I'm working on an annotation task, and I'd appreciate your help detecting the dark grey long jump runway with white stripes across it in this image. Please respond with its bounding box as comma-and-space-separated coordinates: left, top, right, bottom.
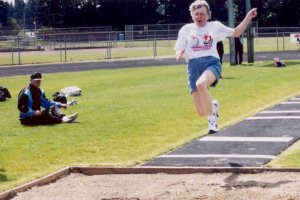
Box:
142, 96, 300, 167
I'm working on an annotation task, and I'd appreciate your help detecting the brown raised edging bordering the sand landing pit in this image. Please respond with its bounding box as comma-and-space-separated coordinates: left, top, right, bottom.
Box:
0, 166, 300, 200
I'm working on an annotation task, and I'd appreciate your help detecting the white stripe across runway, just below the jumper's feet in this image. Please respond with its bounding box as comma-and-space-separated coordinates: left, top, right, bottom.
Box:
198, 136, 294, 142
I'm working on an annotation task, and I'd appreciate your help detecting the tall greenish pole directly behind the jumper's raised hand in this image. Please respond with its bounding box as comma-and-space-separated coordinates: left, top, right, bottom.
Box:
246, 0, 254, 63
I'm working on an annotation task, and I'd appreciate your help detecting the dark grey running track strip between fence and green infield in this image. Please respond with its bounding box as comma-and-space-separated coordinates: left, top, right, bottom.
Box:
0, 51, 300, 77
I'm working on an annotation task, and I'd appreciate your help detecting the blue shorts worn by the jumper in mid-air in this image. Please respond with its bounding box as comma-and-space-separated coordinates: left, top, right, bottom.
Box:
187, 56, 222, 93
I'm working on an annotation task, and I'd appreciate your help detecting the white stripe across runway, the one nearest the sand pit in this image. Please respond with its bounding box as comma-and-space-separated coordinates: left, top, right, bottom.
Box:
159, 154, 276, 159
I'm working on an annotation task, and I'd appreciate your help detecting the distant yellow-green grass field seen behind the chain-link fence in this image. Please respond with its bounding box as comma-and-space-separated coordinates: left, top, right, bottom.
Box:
0, 37, 300, 65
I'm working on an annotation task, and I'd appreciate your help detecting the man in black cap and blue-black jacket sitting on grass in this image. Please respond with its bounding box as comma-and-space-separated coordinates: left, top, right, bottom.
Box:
18, 72, 78, 125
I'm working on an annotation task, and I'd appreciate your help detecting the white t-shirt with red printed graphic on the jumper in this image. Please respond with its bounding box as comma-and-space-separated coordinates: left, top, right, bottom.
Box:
175, 21, 234, 61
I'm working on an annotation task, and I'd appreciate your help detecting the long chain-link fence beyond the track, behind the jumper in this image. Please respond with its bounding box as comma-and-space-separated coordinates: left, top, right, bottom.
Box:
0, 24, 300, 65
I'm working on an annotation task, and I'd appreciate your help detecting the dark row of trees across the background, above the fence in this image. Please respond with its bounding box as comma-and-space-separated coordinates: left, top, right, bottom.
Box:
0, 0, 300, 30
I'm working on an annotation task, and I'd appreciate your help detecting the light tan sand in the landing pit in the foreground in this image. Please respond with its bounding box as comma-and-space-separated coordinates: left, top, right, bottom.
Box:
14, 172, 300, 200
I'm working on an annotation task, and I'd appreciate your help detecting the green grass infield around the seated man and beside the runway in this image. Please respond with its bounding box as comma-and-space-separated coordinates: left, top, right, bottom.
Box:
0, 61, 300, 191
